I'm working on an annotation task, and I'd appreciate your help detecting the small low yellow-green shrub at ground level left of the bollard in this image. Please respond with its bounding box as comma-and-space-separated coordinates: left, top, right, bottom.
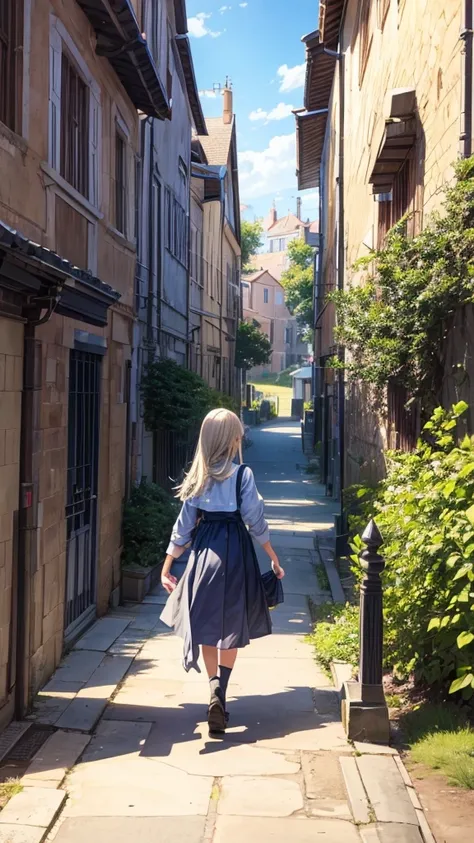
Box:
310, 603, 359, 670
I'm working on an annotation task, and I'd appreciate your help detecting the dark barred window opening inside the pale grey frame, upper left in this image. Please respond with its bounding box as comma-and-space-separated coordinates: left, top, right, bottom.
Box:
60, 52, 89, 196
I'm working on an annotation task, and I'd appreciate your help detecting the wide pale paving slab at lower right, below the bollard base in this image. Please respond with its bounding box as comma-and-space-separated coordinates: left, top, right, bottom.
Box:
356, 755, 418, 826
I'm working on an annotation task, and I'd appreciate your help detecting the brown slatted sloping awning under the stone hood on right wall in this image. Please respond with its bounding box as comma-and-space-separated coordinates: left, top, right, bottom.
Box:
369, 118, 416, 194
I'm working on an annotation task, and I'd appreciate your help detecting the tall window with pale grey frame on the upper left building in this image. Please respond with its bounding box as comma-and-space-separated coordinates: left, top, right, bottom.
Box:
49, 16, 100, 207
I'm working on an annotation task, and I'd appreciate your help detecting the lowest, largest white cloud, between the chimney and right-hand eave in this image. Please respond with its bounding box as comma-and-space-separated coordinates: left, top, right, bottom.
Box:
239, 132, 296, 202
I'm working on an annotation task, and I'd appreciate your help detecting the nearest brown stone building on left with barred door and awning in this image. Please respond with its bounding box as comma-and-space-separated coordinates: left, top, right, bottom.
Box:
0, 0, 165, 725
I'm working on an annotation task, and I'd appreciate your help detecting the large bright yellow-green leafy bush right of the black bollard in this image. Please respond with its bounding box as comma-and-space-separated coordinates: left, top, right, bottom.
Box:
352, 402, 474, 699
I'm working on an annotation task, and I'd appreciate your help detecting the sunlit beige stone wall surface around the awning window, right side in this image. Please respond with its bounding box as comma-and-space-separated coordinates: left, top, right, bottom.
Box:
322, 0, 462, 485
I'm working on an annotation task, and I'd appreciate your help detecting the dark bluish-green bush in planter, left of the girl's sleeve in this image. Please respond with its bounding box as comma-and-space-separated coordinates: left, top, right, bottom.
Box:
122, 481, 180, 568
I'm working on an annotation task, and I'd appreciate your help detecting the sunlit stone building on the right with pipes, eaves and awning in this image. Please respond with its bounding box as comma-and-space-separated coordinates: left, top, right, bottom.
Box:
296, 0, 474, 495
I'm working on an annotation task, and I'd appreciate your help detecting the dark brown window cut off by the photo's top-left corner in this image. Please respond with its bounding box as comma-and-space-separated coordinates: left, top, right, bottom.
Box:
0, 0, 23, 132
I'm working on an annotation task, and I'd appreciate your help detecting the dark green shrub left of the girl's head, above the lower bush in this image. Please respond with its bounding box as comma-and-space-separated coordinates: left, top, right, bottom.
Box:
140, 360, 237, 432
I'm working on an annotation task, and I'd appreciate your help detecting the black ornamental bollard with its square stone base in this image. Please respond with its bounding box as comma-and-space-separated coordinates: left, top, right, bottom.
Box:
342, 520, 390, 743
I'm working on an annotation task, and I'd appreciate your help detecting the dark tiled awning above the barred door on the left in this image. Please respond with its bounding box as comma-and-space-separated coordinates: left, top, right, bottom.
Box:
0, 222, 120, 327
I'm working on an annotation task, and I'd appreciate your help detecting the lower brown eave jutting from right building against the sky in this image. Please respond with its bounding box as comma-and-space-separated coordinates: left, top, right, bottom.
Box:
295, 108, 328, 190
